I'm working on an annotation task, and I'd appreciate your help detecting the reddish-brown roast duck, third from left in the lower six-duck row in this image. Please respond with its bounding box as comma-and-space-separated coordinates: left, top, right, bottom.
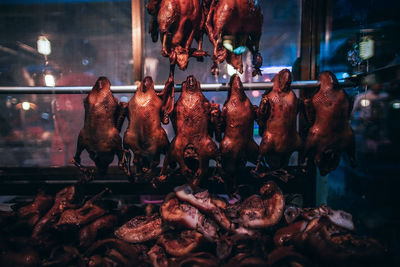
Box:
160, 76, 220, 186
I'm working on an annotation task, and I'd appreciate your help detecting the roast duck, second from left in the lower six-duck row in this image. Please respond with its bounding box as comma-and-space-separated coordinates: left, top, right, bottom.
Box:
124, 77, 175, 181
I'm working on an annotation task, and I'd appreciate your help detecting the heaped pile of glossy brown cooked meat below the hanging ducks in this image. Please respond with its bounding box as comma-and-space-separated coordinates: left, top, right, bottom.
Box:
0, 184, 388, 266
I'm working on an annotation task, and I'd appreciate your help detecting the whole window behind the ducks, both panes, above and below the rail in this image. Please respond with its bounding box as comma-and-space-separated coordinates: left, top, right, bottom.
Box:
0, 0, 301, 166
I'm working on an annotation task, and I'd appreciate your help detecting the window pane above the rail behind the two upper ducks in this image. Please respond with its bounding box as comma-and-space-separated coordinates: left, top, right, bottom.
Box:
143, 0, 301, 84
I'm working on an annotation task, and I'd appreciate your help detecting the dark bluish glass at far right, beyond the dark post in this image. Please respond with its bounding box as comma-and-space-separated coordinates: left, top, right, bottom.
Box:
317, 0, 400, 261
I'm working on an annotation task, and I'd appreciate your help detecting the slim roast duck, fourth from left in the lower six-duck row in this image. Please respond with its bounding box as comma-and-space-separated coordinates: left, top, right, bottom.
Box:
219, 74, 258, 193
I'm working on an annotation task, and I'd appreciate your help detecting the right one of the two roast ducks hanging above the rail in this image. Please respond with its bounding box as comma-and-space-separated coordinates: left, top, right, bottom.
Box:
206, 0, 263, 76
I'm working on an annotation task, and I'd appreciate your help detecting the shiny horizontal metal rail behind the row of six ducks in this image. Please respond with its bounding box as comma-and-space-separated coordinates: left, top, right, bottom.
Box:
0, 81, 355, 94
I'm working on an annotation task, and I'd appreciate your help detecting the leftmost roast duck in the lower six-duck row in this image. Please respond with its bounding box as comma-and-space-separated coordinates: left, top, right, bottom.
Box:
72, 77, 126, 180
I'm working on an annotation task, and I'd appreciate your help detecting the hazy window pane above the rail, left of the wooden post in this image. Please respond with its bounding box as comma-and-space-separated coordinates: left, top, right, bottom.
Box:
0, 0, 133, 86
